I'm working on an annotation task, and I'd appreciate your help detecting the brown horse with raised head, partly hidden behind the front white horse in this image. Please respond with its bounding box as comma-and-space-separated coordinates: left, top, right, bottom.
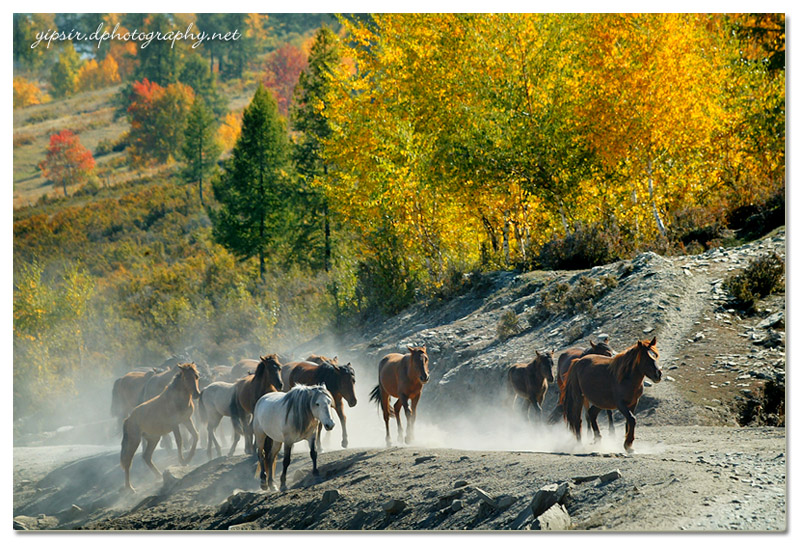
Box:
231, 354, 283, 454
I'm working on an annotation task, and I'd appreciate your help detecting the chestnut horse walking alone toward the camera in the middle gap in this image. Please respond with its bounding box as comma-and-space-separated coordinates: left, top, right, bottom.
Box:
369, 346, 430, 446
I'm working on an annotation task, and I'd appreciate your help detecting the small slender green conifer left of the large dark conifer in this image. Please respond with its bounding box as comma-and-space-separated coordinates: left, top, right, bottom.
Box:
181, 97, 222, 206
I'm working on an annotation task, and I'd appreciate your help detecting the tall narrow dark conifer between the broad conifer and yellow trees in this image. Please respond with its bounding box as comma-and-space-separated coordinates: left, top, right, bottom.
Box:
291, 27, 340, 271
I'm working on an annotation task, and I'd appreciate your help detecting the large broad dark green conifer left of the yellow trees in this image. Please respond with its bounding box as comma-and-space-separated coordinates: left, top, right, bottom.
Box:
209, 84, 291, 280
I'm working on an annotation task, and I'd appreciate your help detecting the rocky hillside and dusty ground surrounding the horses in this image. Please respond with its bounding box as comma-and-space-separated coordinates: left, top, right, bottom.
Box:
14, 229, 787, 531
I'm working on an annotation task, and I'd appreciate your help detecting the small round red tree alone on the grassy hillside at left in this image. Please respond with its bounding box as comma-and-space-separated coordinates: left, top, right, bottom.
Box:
39, 129, 95, 197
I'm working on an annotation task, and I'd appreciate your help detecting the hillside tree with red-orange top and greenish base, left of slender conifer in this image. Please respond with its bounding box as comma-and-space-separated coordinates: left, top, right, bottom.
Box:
127, 79, 194, 165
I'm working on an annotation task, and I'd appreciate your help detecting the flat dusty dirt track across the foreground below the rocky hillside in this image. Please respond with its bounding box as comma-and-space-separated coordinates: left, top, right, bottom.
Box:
15, 426, 786, 531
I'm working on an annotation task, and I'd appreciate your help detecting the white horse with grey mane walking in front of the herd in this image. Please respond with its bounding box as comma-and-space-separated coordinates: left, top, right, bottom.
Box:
253, 384, 334, 490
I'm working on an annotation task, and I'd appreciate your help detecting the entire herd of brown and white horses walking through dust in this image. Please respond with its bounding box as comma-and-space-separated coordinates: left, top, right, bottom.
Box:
111, 338, 661, 491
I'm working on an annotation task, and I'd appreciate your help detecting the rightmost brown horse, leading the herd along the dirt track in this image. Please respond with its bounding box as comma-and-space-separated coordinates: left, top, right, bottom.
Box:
559, 337, 661, 452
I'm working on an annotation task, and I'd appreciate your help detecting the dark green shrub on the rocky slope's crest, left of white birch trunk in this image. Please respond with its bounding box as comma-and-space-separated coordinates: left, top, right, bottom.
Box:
538, 224, 622, 270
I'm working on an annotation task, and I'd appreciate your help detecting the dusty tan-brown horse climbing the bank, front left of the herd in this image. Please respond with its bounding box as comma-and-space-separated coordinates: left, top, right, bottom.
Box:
120, 363, 200, 491
